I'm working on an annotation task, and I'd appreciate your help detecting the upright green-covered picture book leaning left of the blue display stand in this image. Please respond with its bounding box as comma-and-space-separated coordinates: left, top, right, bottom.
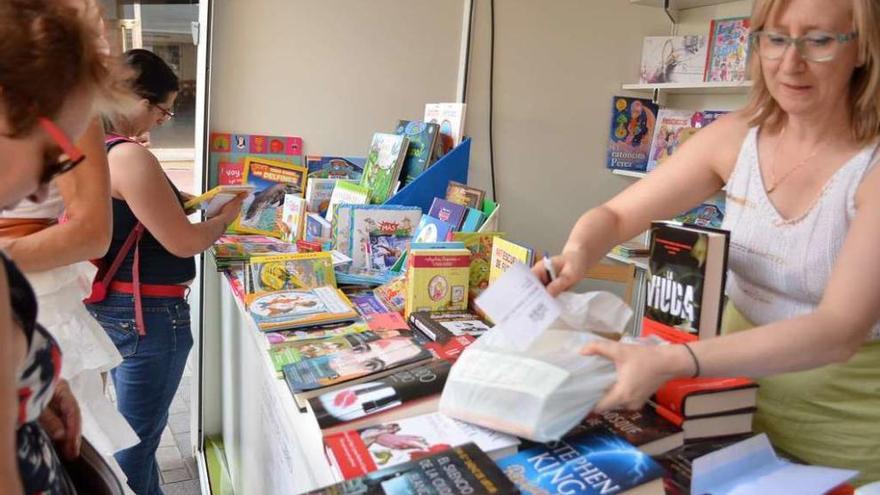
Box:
360, 133, 409, 204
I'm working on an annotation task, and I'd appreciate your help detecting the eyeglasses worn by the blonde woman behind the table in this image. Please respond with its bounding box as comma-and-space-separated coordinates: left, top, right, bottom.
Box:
751, 31, 858, 62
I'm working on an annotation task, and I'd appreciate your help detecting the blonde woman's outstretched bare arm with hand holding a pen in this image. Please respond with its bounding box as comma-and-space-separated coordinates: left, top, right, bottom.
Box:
534, 114, 748, 295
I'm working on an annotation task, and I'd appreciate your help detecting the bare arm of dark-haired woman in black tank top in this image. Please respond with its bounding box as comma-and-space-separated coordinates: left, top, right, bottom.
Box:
109, 143, 244, 258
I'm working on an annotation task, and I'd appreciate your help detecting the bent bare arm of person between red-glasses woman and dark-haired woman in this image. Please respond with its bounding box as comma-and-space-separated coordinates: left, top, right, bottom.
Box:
4, 119, 112, 272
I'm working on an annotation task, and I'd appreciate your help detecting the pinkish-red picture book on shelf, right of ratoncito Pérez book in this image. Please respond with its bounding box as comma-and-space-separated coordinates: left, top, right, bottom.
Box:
647, 108, 727, 172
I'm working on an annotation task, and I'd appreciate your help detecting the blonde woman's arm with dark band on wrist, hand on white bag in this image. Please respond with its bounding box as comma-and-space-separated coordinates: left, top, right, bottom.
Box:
584, 167, 880, 409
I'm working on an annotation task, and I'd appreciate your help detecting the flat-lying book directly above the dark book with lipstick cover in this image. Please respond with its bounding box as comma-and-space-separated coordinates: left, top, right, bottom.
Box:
284, 331, 432, 401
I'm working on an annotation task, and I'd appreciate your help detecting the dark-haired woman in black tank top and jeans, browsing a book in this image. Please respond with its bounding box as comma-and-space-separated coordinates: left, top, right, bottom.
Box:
89, 50, 242, 495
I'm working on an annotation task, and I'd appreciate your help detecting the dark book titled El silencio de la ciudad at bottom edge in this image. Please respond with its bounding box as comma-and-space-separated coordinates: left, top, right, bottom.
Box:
307, 443, 519, 495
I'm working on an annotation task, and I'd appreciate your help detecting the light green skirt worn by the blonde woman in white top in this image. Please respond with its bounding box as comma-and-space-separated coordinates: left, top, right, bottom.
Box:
722, 303, 880, 485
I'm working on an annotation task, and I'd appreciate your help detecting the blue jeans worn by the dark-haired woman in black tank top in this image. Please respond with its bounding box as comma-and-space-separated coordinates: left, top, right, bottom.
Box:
88, 293, 193, 495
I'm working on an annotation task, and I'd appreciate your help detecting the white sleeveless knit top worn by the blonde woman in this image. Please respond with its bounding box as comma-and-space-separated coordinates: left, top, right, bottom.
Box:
722, 128, 880, 340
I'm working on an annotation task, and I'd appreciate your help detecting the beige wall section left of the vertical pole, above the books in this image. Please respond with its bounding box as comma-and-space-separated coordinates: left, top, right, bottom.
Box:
210, 0, 462, 156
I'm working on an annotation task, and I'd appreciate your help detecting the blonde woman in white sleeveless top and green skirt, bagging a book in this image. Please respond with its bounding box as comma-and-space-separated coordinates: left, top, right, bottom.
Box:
535, 0, 880, 483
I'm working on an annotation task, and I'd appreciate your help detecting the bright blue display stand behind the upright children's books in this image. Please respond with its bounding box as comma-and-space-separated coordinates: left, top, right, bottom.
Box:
385, 138, 471, 214
